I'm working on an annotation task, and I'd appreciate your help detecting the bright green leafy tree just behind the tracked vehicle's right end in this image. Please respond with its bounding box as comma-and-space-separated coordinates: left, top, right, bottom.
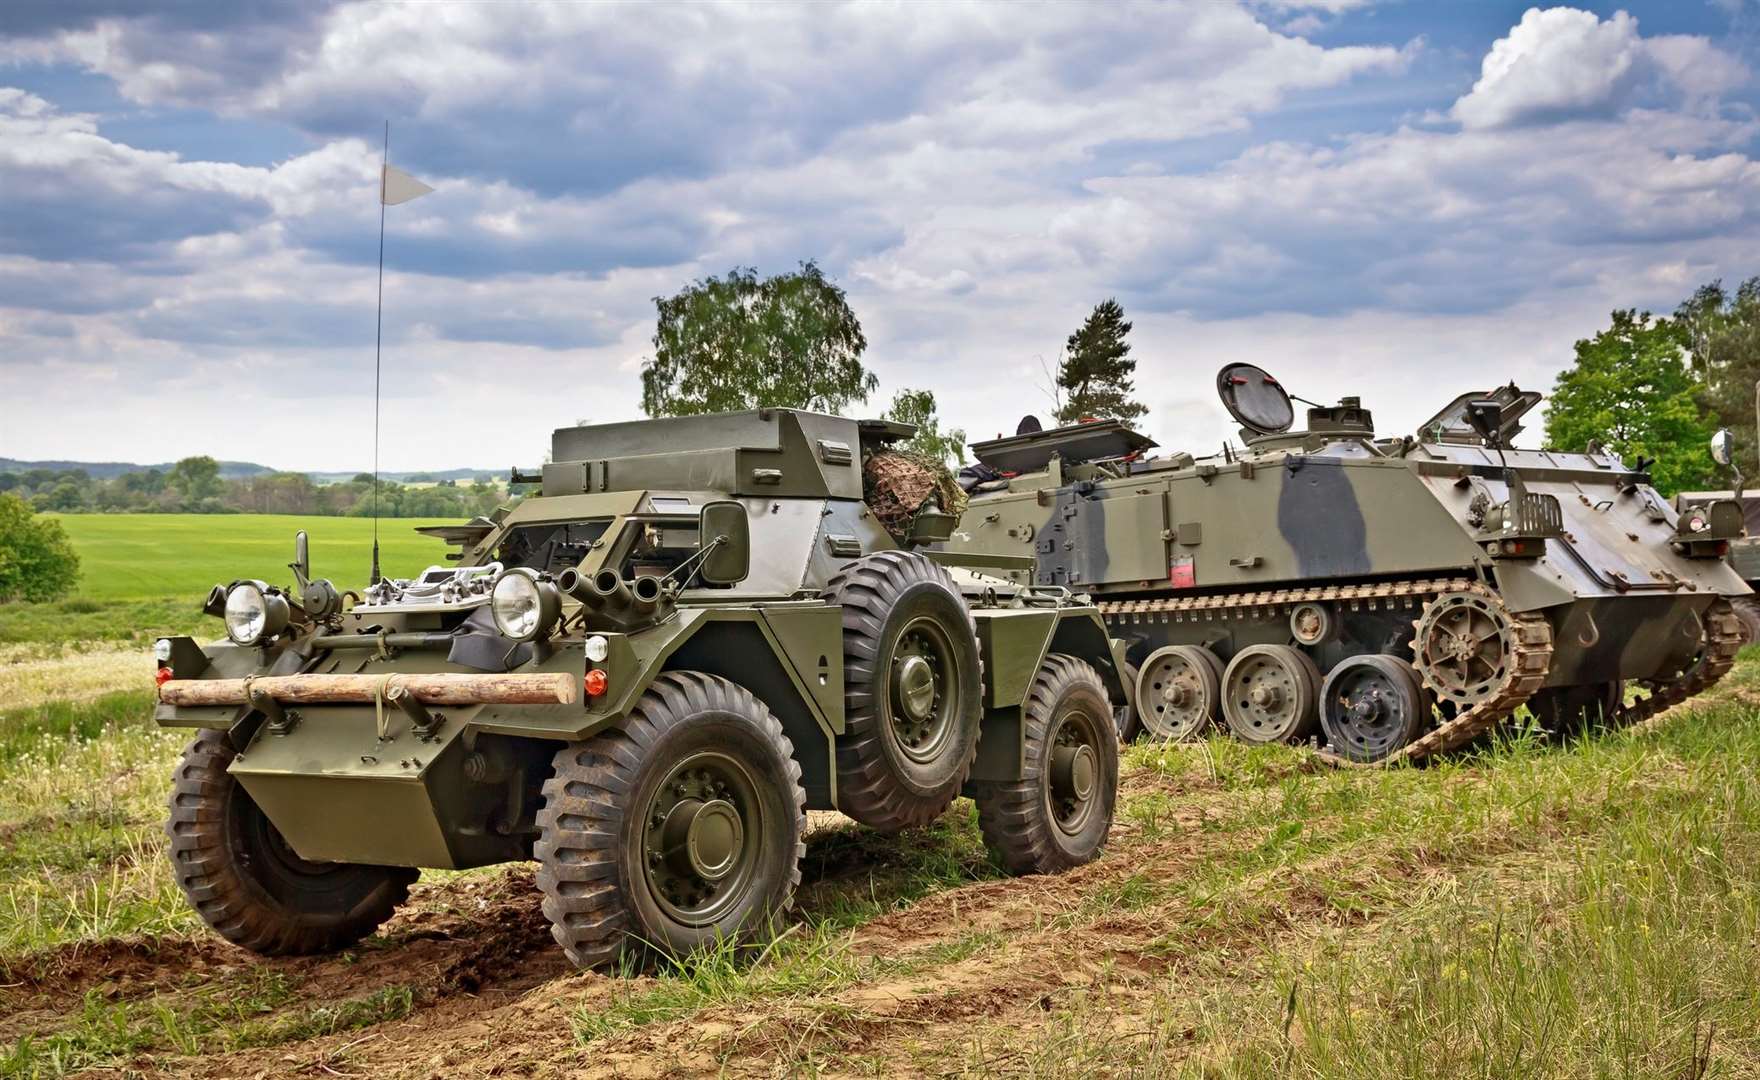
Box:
1545, 310, 1720, 494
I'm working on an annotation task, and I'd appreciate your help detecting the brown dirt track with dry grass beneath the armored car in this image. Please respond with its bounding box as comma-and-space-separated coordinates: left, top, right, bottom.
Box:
0, 735, 1661, 1078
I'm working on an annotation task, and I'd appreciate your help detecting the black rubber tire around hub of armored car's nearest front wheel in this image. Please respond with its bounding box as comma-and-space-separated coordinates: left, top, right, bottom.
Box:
533, 672, 806, 967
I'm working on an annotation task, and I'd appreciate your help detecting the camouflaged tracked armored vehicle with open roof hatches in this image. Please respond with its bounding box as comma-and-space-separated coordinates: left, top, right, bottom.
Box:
947, 364, 1748, 763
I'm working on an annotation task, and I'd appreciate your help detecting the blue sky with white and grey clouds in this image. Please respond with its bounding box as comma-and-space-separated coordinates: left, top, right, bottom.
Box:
0, 0, 1760, 470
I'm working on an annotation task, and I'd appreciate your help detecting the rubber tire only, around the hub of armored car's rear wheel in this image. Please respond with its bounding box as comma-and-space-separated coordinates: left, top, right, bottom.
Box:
975, 653, 1118, 874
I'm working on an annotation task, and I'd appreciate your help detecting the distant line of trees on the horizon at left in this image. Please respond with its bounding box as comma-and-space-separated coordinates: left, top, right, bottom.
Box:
0, 457, 507, 517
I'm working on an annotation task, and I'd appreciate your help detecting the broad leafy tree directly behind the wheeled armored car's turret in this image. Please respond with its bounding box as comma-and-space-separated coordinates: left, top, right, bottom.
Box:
642, 262, 876, 417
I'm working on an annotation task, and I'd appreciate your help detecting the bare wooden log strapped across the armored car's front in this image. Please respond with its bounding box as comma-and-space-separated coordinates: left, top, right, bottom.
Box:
158, 672, 581, 705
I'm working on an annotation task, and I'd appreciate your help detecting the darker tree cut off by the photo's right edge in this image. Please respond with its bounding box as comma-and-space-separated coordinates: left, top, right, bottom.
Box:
1674, 278, 1760, 475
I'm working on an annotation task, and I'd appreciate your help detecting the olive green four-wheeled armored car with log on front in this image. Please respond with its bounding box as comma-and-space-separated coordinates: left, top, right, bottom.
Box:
157, 410, 1126, 966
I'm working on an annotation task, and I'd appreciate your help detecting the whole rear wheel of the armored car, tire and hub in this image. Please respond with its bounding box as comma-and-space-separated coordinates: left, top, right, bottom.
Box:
977, 654, 1118, 874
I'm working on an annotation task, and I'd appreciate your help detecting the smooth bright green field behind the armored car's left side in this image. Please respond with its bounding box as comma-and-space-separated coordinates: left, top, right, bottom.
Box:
0, 514, 454, 644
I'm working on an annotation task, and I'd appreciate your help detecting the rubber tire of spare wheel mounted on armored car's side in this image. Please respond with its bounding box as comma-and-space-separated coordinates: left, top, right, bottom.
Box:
822, 551, 982, 832
